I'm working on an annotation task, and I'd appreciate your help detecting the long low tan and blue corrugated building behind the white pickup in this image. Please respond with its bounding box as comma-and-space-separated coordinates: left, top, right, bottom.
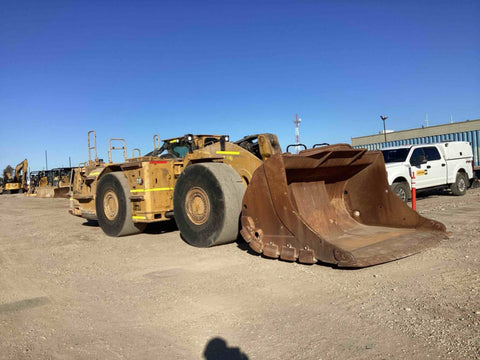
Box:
352, 119, 480, 168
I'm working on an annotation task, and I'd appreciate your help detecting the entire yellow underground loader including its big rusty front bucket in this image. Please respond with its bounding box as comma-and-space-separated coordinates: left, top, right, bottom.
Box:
70, 131, 446, 268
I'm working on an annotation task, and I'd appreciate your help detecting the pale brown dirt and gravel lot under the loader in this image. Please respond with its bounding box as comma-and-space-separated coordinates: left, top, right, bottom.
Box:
0, 189, 480, 359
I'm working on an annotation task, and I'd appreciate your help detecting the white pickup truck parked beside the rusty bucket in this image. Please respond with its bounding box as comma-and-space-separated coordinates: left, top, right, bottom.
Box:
382, 141, 473, 202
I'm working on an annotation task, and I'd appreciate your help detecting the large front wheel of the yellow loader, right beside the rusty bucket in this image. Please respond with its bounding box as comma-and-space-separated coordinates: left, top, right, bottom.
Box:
173, 163, 245, 247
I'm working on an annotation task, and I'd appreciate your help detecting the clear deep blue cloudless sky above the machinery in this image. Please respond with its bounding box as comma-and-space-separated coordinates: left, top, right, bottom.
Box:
0, 0, 480, 170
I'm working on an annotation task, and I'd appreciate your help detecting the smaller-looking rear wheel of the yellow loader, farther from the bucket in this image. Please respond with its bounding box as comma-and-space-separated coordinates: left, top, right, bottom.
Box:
95, 172, 146, 236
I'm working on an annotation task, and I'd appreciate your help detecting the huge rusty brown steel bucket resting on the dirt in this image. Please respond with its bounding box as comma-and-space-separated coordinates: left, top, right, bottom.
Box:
241, 144, 447, 268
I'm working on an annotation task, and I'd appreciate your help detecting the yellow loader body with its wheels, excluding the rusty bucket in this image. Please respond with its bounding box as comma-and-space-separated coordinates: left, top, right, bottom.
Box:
70, 132, 281, 247
